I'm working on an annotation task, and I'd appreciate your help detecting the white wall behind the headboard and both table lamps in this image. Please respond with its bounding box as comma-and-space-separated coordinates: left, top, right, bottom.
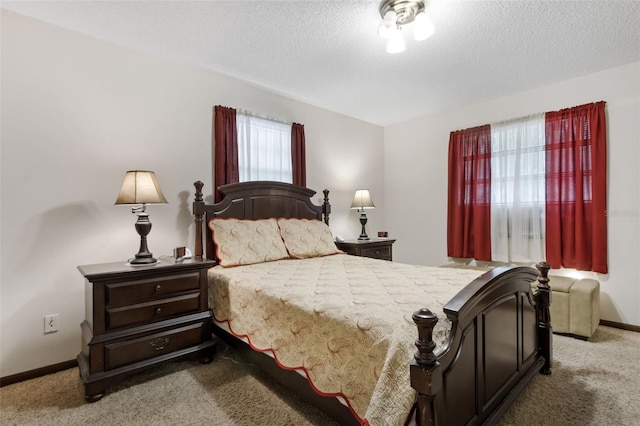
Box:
0, 10, 385, 377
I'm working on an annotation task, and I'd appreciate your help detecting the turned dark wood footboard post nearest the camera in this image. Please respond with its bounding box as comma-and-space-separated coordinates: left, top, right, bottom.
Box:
410, 308, 442, 426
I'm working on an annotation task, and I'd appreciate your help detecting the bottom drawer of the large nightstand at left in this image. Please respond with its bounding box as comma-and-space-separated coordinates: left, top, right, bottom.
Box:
104, 322, 205, 370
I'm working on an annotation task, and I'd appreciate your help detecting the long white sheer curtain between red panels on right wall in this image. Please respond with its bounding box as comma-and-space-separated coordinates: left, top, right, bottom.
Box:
491, 114, 545, 262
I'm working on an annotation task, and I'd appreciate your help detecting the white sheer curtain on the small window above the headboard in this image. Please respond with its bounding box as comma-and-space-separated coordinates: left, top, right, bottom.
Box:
236, 111, 293, 183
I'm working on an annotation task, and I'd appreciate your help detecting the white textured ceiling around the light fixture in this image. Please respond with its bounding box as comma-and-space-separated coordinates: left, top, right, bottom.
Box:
1, 0, 640, 125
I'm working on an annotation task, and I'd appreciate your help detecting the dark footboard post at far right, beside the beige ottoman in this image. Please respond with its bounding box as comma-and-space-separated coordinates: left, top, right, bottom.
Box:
535, 262, 553, 374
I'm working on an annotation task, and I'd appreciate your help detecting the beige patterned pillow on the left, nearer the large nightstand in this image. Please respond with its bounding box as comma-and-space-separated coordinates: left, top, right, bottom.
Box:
209, 219, 289, 266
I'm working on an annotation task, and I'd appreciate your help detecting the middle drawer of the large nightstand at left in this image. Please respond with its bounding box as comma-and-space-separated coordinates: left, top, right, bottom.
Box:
106, 292, 200, 330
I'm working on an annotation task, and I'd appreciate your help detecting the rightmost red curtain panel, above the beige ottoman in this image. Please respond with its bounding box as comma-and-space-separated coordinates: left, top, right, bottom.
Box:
545, 102, 607, 273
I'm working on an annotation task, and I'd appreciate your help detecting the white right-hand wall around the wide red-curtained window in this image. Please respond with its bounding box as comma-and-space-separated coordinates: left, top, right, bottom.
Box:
384, 63, 640, 325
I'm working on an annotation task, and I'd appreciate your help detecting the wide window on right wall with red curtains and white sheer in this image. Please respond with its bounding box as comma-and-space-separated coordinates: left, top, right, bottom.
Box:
447, 101, 608, 273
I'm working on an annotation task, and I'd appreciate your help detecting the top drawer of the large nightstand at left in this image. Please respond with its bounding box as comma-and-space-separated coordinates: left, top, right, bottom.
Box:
106, 272, 200, 306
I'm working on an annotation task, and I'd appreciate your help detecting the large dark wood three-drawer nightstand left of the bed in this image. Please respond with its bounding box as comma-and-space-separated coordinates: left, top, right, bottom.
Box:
77, 258, 215, 402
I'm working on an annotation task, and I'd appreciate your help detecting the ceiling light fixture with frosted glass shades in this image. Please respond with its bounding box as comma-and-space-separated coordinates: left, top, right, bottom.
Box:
378, 0, 435, 53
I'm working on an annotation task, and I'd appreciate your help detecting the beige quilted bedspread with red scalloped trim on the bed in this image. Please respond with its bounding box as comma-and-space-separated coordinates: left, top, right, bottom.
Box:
209, 254, 482, 425
